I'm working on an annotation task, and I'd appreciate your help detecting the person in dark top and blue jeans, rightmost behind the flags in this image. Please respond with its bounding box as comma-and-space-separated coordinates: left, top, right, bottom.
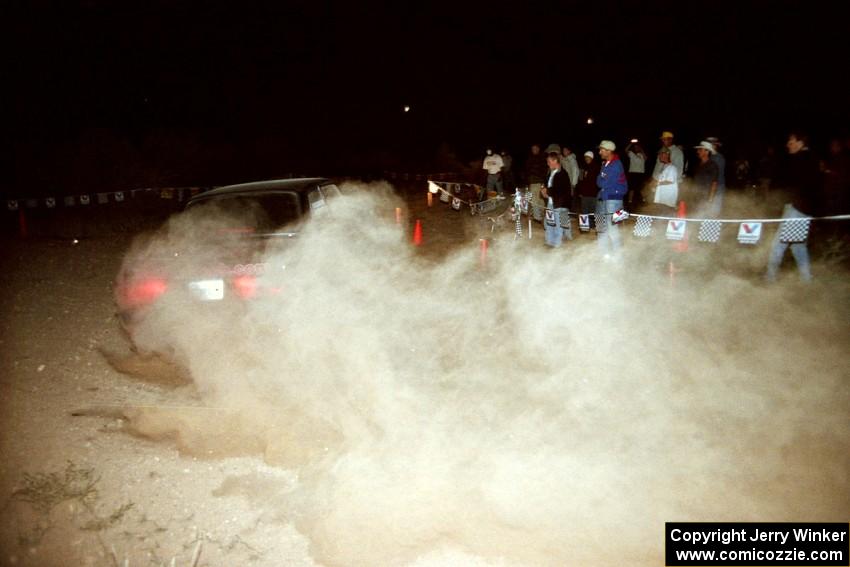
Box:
765, 132, 820, 282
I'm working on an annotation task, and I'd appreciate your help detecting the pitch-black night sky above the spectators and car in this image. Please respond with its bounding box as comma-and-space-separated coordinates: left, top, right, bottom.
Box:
2, 0, 850, 191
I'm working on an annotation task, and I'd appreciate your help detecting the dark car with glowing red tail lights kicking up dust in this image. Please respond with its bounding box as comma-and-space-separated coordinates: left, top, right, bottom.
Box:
115, 177, 341, 337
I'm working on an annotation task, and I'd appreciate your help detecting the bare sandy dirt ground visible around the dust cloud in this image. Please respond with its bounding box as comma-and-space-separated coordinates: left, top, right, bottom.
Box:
0, 183, 846, 566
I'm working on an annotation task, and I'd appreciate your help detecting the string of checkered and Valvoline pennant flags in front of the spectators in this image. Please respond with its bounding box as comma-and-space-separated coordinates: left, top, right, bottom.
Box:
428, 179, 850, 244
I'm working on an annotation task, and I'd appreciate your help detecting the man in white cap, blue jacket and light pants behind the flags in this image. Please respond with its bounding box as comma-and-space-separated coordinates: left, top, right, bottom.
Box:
596, 140, 629, 259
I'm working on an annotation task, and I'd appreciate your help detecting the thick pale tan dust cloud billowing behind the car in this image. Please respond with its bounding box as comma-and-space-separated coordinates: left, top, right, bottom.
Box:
122, 184, 850, 566
